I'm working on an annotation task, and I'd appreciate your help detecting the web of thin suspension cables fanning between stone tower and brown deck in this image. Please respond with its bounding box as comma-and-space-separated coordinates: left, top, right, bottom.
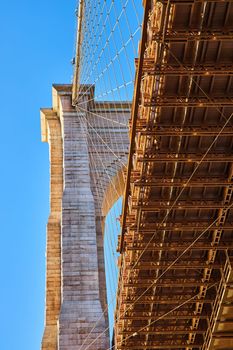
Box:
72, 0, 142, 347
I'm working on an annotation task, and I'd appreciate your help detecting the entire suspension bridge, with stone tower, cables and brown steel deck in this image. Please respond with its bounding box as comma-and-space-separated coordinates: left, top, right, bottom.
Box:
41, 0, 233, 350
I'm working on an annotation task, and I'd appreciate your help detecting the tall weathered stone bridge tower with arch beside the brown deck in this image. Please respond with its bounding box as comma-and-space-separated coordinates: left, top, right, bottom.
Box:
41, 85, 130, 350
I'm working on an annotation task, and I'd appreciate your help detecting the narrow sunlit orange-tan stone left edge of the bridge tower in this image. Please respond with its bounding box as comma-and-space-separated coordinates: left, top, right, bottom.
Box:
41, 109, 63, 350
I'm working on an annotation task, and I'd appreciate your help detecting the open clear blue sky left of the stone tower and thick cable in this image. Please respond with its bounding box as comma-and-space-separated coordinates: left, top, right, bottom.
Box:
0, 0, 76, 350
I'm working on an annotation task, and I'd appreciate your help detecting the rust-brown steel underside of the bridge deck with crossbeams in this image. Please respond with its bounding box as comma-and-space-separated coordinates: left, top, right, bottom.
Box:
115, 1, 233, 350
